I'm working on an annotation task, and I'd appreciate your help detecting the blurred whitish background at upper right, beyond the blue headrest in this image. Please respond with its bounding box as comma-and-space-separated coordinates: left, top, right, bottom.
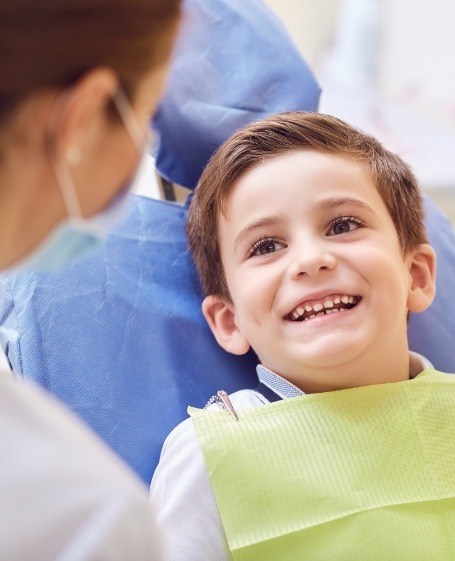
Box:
266, 0, 455, 224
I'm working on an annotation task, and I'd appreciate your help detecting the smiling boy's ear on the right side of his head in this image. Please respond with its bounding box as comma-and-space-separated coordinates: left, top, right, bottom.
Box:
408, 243, 436, 312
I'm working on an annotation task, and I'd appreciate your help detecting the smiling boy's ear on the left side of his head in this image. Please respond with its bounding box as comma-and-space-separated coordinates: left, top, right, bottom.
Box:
202, 295, 250, 355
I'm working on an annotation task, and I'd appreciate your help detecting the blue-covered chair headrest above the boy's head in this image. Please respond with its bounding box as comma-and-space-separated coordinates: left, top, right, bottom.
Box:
153, 0, 320, 188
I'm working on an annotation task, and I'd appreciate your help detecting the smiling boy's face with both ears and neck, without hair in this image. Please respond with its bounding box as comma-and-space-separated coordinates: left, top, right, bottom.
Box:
203, 150, 434, 391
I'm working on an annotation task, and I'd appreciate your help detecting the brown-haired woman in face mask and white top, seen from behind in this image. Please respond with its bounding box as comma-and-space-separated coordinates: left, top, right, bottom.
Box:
0, 0, 180, 561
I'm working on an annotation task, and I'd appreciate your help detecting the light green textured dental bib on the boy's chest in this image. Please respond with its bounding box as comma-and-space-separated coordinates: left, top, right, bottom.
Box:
189, 370, 455, 561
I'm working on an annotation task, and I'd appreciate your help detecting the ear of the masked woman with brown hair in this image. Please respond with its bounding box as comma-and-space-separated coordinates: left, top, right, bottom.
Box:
49, 67, 118, 164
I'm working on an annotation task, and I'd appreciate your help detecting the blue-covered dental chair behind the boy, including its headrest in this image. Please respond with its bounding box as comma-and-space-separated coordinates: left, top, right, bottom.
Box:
0, 0, 455, 483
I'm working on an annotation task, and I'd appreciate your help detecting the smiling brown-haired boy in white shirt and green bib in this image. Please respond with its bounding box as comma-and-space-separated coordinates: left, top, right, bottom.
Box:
151, 113, 455, 560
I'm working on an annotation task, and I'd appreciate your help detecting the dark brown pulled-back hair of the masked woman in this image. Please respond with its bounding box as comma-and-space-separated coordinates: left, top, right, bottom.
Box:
0, 0, 180, 123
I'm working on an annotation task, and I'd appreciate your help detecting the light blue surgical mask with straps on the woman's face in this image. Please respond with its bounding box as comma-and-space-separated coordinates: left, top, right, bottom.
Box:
12, 90, 148, 271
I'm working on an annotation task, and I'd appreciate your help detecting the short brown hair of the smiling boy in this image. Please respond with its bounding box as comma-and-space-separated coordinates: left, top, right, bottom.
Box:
187, 112, 427, 299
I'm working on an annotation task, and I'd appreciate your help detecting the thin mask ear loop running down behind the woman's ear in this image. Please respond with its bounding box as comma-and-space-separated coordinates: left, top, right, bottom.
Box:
45, 91, 82, 221
